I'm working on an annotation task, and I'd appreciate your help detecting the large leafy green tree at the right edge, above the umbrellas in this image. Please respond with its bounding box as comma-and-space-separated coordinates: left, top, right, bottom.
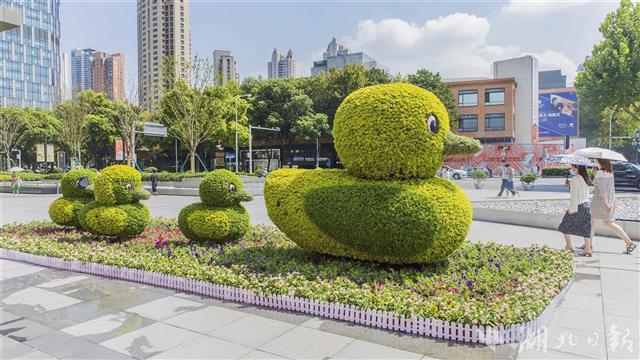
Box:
574, 0, 640, 142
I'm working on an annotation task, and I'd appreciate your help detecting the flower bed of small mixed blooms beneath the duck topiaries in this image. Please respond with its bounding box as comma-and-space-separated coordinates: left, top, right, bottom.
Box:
0, 219, 573, 334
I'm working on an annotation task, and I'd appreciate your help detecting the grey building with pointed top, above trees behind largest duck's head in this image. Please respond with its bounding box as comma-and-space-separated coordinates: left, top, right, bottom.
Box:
311, 38, 389, 76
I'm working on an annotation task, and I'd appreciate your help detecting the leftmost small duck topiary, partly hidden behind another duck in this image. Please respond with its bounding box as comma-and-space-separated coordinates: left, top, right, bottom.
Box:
49, 169, 96, 227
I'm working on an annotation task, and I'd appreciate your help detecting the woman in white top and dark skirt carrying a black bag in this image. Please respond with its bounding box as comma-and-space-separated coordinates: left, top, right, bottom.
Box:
558, 165, 591, 257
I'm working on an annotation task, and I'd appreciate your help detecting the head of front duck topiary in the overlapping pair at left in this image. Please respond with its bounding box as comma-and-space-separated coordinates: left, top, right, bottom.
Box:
93, 165, 151, 205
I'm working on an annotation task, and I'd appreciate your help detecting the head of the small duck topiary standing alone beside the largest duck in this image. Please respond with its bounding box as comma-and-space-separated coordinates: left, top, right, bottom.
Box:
200, 169, 253, 207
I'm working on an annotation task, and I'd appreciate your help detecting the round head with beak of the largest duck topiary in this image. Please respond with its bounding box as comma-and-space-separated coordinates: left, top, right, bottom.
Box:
333, 83, 480, 179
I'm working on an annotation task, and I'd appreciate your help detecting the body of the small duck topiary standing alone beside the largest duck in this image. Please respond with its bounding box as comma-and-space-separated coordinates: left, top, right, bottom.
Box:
178, 203, 250, 242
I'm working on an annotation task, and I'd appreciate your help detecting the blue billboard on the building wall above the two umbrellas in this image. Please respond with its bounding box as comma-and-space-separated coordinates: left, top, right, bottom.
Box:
538, 91, 578, 137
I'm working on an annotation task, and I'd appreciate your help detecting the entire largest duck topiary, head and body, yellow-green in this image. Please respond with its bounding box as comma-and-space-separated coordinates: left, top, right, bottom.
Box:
265, 83, 478, 264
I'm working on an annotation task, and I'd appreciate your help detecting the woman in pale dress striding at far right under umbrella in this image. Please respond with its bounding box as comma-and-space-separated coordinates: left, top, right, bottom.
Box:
580, 159, 637, 254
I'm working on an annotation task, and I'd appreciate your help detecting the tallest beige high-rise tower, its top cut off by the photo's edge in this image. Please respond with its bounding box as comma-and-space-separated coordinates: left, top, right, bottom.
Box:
138, 0, 191, 110
